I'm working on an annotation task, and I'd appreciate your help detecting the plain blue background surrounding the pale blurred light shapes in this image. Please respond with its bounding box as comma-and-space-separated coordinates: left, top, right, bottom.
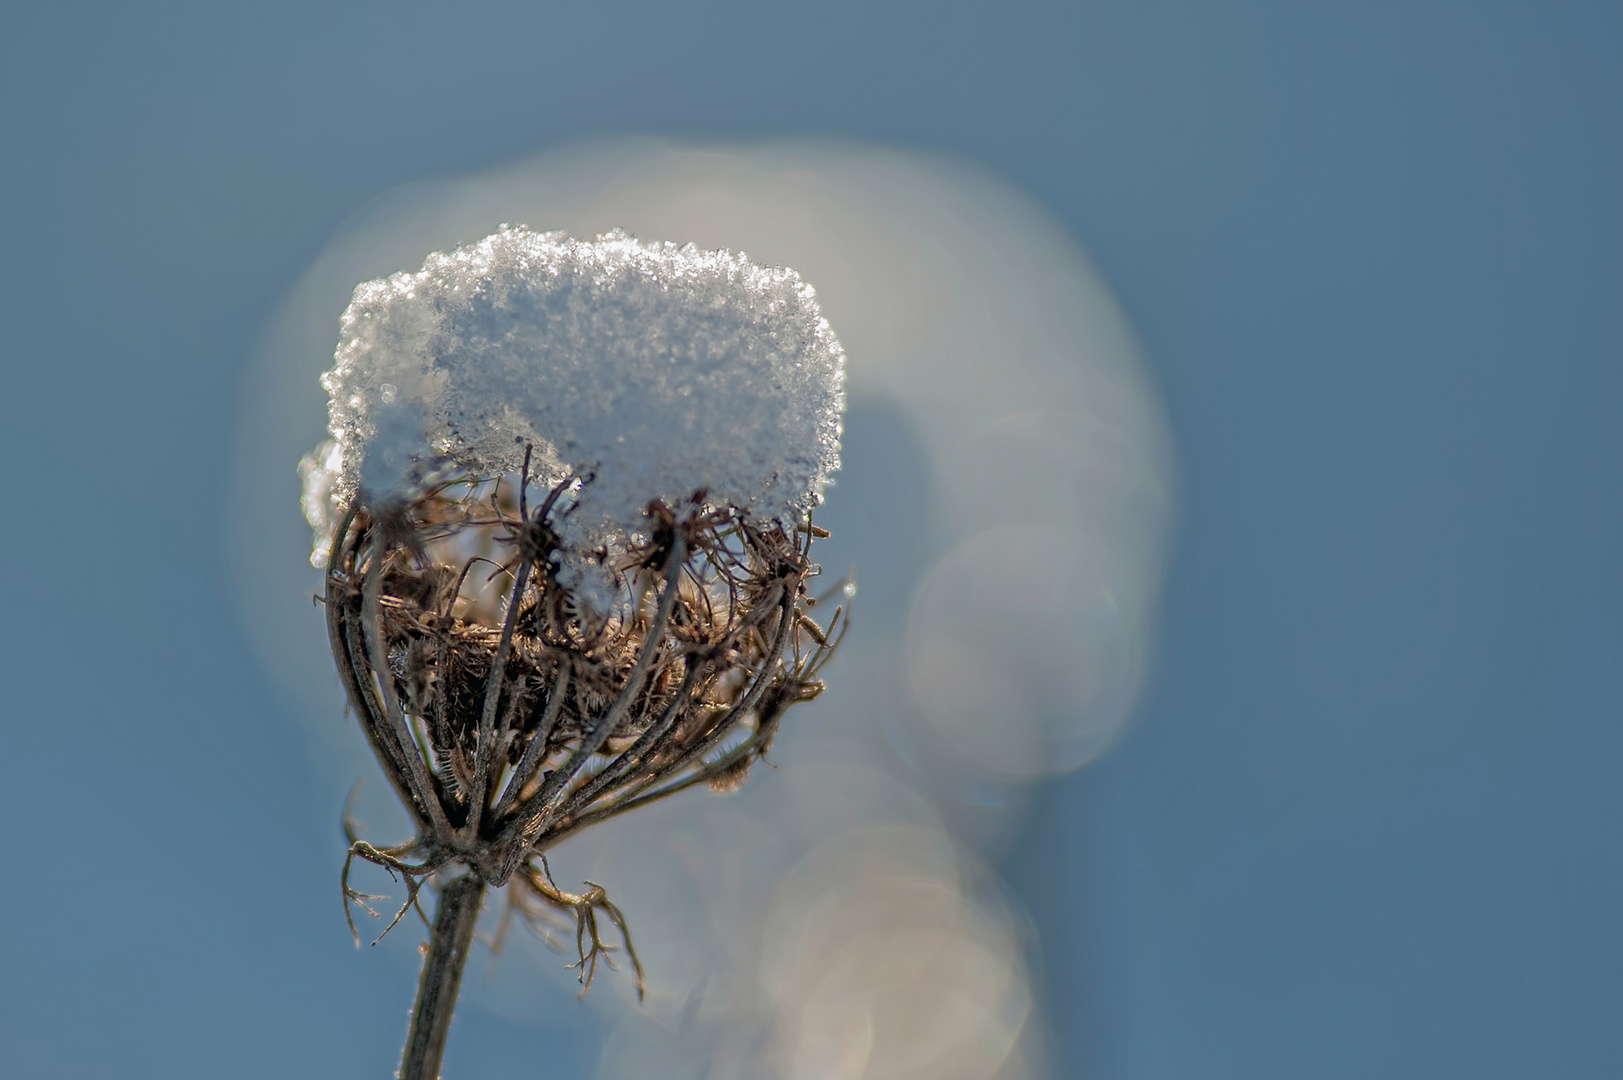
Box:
0, 0, 1623, 1080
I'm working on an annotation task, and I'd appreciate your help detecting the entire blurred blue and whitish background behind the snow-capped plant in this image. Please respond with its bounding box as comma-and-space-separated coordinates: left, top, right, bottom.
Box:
0, 0, 1623, 1078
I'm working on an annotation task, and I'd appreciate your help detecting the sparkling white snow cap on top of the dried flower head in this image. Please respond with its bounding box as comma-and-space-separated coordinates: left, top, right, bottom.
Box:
300, 226, 844, 584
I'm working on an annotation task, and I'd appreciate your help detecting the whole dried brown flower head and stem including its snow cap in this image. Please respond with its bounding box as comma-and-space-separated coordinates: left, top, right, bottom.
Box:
302, 227, 844, 1077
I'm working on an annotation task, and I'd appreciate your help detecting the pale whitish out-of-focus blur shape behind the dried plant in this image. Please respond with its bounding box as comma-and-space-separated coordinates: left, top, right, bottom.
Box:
230, 140, 1172, 1080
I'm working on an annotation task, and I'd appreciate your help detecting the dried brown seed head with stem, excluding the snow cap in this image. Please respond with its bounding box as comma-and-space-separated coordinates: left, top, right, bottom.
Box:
325, 460, 846, 1080
